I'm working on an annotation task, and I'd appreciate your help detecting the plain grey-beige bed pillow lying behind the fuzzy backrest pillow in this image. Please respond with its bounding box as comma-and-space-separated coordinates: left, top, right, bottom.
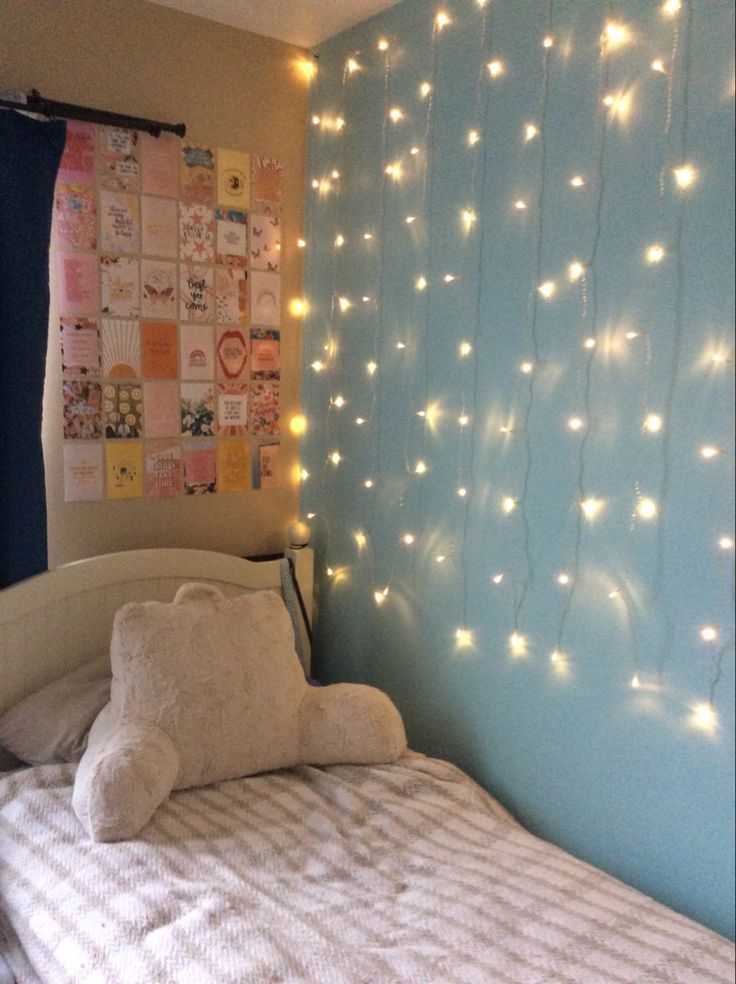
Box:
0, 656, 110, 765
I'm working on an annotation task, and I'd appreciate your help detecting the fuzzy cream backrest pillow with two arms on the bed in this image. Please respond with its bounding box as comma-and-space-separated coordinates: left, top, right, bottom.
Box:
73, 584, 406, 841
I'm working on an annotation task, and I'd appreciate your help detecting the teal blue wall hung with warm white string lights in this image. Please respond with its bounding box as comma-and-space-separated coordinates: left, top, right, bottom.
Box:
302, 0, 734, 935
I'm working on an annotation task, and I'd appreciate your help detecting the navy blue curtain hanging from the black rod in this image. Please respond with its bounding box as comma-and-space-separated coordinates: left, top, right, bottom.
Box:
0, 109, 66, 588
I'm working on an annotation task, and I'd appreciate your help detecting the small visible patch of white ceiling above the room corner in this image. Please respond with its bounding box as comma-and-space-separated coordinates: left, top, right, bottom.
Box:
147, 0, 406, 48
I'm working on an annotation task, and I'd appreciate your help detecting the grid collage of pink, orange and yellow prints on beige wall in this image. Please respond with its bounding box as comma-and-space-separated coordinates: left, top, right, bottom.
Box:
54, 122, 283, 502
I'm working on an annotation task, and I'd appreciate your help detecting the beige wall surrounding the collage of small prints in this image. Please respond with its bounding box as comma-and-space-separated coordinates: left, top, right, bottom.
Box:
0, 0, 307, 566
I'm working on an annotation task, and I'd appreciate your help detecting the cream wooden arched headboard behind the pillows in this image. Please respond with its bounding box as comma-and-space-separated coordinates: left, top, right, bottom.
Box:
0, 549, 314, 714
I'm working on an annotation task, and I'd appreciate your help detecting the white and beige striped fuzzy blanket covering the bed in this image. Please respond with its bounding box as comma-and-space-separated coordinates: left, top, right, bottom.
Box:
0, 753, 734, 984
